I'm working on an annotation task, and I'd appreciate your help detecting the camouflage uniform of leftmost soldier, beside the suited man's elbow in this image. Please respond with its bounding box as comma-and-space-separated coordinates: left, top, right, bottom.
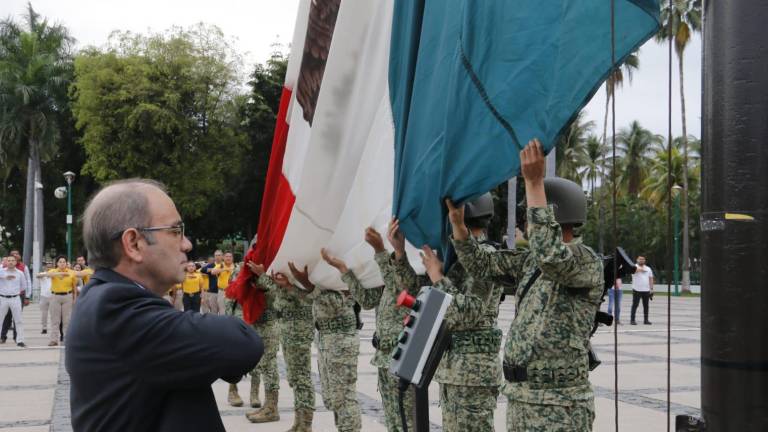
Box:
250, 274, 280, 393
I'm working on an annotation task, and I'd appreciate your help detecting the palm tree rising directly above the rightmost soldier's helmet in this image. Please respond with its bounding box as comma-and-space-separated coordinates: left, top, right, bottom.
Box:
555, 111, 595, 183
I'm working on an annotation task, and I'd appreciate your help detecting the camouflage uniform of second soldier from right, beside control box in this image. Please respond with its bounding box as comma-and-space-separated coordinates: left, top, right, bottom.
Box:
397, 236, 503, 432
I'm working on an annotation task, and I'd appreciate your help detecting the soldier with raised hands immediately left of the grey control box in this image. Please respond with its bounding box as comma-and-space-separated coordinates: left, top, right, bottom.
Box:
322, 219, 418, 432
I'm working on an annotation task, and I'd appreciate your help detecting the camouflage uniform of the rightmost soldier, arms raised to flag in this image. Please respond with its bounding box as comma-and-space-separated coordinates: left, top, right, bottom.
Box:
454, 206, 603, 431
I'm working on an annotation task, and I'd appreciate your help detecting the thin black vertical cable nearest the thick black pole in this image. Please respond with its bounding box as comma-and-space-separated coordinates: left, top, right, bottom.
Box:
667, 0, 674, 432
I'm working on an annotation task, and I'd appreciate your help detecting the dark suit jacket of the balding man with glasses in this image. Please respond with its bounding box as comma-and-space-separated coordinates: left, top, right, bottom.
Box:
65, 269, 263, 432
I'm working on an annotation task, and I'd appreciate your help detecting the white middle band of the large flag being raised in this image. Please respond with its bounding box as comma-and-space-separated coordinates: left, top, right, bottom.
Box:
272, 0, 426, 289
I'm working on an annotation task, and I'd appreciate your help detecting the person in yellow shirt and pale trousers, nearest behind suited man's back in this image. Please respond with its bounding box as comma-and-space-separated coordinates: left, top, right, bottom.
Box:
37, 256, 77, 346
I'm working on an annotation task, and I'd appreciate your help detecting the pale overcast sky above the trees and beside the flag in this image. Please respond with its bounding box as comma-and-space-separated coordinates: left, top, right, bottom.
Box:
0, 0, 701, 137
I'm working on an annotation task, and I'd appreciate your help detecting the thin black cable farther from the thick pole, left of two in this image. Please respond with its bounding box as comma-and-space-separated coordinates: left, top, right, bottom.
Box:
606, 0, 619, 432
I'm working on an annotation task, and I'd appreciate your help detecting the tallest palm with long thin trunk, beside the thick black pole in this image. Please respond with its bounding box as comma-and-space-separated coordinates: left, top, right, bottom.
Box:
656, 0, 701, 291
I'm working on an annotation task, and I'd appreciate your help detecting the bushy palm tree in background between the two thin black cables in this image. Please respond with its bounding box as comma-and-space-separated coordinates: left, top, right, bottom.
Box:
616, 120, 662, 196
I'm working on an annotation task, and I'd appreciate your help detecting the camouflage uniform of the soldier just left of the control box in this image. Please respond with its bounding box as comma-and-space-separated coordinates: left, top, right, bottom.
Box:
342, 252, 418, 432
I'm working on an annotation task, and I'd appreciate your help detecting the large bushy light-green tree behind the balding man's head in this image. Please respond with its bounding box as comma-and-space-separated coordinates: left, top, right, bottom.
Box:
71, 24, 246, 228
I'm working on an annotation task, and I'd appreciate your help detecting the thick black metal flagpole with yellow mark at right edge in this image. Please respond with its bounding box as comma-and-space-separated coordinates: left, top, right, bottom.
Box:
701, 0, 768, 431
